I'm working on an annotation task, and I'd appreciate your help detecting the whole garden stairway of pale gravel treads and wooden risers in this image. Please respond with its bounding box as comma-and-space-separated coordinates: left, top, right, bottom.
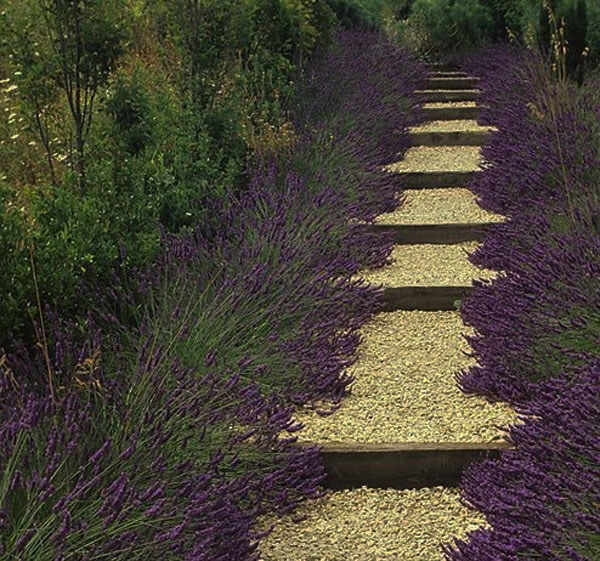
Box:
255, 62, 516, 561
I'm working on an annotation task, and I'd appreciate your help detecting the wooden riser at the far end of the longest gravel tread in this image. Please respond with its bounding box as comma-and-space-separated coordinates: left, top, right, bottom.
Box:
381, 286, 473, 312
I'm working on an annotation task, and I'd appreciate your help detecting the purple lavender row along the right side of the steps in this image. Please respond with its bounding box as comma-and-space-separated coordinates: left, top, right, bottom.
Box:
445, 46, 600, 561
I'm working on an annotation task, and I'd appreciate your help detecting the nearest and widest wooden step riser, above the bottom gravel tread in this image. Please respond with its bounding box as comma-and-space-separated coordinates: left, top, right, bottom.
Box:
300, 442, 511, 490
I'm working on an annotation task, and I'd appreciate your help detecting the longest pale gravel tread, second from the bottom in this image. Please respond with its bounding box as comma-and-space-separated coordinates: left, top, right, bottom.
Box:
294, 310, 517, 442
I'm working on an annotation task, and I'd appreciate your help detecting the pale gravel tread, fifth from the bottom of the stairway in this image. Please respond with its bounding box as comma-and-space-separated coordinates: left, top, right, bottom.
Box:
385, 146, 482, 172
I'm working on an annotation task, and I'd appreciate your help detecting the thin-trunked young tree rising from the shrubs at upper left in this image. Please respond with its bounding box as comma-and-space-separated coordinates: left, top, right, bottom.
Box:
2, 0, 125, 191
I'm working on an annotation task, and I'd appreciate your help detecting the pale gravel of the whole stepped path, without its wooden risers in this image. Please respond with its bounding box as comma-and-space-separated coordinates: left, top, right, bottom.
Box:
256, 74, 510, 561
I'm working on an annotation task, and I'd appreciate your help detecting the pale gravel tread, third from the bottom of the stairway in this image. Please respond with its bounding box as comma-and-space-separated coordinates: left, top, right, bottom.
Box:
356, 241, 496, 287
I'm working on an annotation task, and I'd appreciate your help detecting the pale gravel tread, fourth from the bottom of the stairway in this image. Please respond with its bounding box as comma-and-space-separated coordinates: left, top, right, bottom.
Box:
375, 187, 505, 224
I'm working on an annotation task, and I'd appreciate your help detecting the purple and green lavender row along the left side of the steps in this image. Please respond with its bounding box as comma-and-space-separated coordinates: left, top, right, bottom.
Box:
0, 32, 424, 561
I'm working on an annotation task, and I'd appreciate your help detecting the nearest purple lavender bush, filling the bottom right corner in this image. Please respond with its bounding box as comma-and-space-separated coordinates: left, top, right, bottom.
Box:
444, 357, 600, 561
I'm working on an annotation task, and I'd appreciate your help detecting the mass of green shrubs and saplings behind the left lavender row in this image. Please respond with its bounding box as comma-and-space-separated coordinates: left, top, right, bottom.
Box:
0, 0, 337, 343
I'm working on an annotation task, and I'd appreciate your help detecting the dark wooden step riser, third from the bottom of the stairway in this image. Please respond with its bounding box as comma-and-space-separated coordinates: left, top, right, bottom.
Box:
365, 223, 496, 245
